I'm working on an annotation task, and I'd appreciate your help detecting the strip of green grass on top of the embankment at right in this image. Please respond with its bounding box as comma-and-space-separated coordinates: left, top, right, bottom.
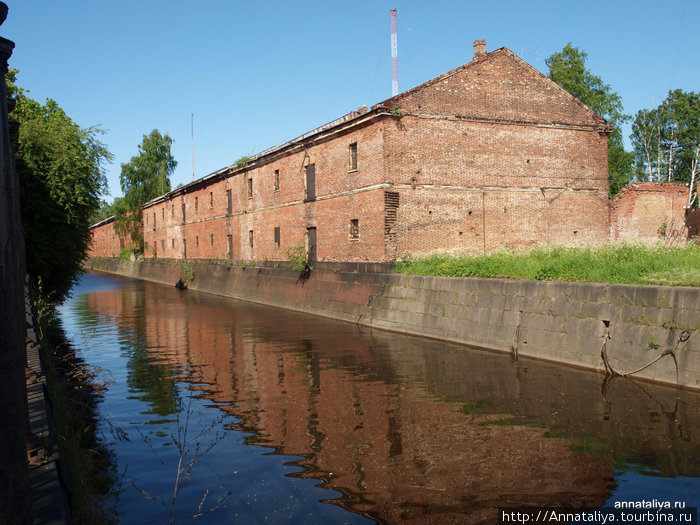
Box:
394, 243, 700, 286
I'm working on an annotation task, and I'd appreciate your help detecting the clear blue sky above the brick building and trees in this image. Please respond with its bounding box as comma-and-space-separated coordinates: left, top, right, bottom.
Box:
5, 0, 700, 201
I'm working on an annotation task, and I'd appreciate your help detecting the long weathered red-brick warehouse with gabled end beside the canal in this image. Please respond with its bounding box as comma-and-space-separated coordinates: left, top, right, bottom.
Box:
93, 40, 610, 262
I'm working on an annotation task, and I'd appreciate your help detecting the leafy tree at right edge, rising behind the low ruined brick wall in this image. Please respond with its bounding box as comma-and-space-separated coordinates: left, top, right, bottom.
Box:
630, 89, 700, 206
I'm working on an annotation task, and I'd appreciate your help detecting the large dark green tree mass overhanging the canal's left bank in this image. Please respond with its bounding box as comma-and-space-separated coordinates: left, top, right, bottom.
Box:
6, 69, 112, 302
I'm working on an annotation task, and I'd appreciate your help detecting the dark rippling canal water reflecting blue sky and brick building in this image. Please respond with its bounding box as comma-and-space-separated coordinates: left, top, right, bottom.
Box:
60, 274, 700, 524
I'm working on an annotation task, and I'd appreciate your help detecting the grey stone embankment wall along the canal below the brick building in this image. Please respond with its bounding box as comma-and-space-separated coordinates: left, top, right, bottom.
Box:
88, 259, 700, 389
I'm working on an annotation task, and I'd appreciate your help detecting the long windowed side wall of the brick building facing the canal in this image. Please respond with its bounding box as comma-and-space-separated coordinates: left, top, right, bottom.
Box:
138, 120, 385, 261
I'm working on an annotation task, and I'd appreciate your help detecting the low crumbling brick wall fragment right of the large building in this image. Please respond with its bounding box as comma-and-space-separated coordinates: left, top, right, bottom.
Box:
610, 182, 688, 241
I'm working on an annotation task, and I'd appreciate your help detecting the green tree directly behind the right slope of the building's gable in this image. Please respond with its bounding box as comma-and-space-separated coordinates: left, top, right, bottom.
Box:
545, 43, 634, 197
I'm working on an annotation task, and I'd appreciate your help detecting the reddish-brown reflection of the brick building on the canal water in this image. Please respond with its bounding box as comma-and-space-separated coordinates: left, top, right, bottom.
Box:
86, 283, 699, 523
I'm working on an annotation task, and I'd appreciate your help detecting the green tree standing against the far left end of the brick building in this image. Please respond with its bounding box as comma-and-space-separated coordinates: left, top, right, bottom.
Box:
114, 129, 177, 251
